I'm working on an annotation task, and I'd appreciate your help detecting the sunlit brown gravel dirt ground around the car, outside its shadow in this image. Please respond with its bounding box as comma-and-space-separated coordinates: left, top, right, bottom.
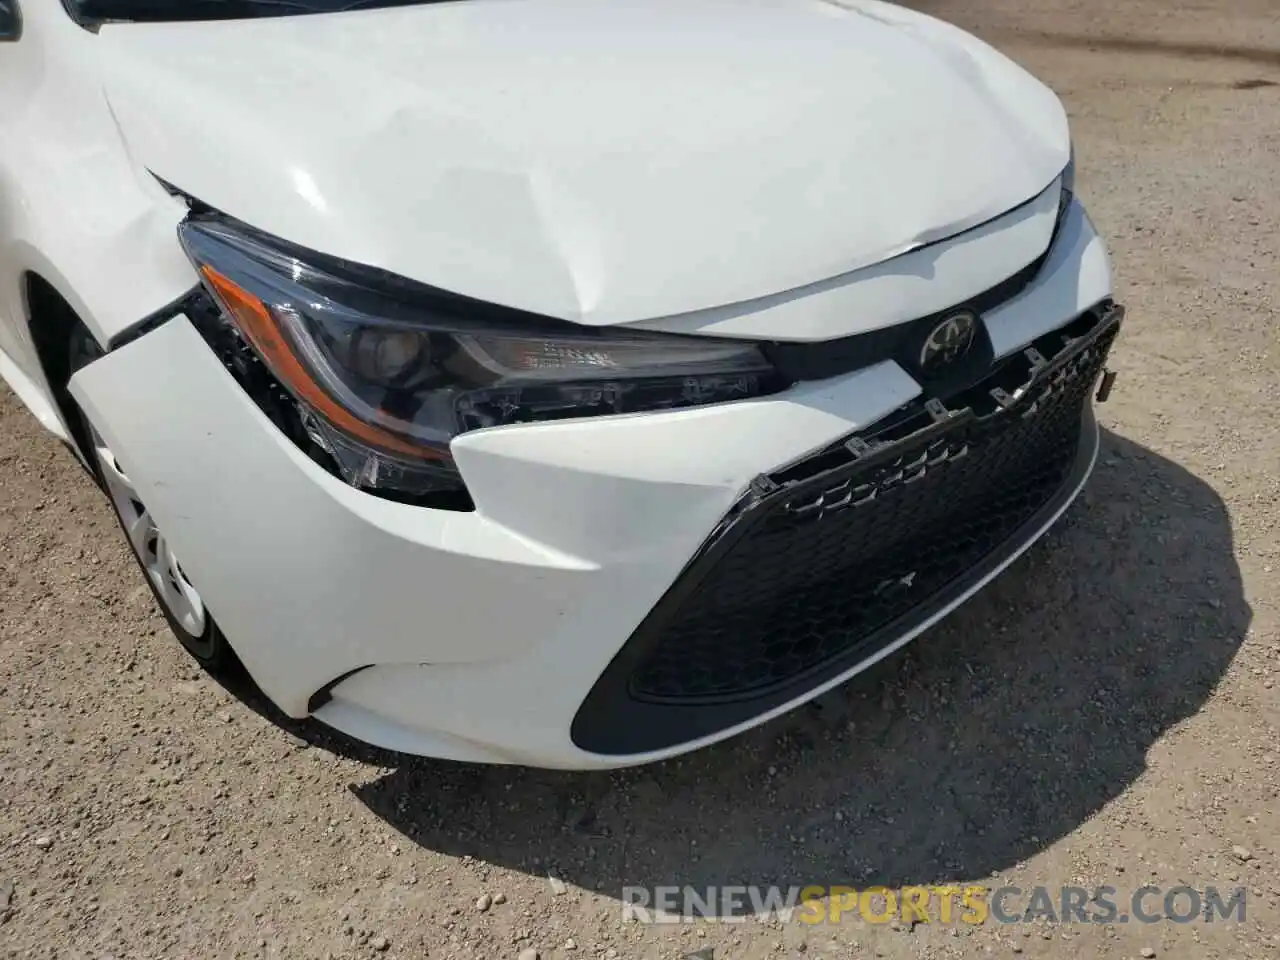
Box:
0, 0, 1280, 960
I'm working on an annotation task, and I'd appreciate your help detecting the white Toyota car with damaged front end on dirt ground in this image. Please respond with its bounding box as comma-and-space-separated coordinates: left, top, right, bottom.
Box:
0, 0, 1123, 768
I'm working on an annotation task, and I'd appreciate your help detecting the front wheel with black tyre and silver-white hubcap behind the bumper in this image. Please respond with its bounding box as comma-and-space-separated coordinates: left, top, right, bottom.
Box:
68, 326, 239, 676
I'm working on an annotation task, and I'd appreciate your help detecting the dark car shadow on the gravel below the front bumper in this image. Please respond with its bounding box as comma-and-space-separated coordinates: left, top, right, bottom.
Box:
252, 431, 1251, 896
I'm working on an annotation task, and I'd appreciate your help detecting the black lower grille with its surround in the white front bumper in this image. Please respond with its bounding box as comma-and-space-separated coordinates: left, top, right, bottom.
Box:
571, 303, 1124, 755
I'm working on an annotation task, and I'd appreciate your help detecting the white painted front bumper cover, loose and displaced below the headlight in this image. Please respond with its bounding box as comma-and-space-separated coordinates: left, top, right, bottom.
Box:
72, 205, 1111, 768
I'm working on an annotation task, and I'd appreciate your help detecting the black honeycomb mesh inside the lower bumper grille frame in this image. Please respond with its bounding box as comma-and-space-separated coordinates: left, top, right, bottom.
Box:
628, 320, 1111, 704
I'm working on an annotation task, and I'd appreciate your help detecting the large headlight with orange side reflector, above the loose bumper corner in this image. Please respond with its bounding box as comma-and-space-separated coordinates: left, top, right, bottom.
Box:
179, 218, 786, 495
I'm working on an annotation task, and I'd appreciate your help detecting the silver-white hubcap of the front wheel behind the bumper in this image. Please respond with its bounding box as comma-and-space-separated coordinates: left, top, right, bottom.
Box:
90, 424, 206, 637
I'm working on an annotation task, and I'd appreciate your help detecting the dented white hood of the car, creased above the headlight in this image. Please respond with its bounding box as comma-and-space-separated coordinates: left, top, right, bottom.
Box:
100, 0, 1069, 324
